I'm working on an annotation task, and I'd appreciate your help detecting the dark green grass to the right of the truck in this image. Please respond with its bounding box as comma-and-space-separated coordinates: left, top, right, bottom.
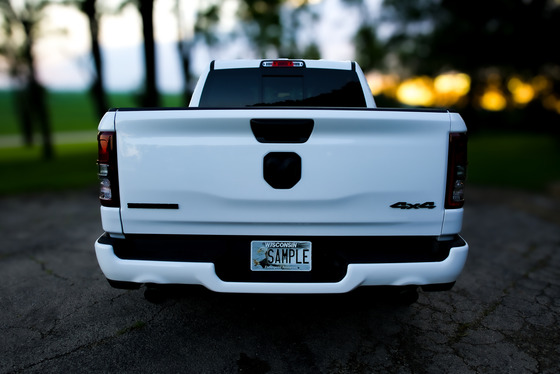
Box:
468, 132, 560, 192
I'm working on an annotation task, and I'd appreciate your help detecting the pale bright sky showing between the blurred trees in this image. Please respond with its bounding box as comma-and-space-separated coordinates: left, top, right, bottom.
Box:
0, 0, 380, 92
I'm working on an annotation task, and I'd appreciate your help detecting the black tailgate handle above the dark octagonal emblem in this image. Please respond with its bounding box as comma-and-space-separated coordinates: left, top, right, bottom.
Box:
251, 118, 314, 143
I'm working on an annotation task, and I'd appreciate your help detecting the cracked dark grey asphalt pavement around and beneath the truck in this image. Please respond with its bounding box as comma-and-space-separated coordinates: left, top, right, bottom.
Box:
0, 189, 560, 373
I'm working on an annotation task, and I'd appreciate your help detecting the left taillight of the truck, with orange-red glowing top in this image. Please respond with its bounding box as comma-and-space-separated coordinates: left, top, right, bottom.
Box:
97, 131, 120, 207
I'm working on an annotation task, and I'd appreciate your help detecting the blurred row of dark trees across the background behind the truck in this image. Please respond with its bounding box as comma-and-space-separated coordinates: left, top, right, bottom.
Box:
0, 0, 560, 158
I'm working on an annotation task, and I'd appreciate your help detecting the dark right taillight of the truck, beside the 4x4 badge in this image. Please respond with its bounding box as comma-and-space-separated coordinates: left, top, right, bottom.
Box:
445, 132, 467, 209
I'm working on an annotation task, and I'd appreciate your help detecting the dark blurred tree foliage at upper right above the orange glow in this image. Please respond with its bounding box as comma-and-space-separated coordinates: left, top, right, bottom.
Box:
383, 0, 560, 76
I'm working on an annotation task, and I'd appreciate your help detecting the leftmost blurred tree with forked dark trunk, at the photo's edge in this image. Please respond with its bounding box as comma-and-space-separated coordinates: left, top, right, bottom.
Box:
0, 0, 54, 159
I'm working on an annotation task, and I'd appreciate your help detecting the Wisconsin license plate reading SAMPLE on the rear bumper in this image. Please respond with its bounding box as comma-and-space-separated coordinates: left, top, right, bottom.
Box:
251, 240, 311, 271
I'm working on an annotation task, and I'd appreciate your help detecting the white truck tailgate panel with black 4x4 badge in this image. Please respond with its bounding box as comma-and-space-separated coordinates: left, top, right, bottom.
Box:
115, 109, 450, 236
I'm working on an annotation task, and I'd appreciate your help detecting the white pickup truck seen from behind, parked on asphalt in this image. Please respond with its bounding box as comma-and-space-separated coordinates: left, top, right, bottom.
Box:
95, 59, 468, 294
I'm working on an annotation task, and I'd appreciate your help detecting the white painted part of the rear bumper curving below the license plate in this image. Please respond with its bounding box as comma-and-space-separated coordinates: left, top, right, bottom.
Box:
95, 235, 469, 294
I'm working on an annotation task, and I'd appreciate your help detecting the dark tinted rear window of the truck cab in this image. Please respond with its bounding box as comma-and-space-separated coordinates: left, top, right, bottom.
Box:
199, 68, 366, 108
